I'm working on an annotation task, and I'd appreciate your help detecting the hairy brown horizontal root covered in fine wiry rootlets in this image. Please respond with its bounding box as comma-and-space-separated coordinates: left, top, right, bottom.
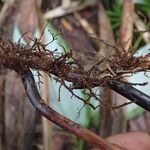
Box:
0, 37, 150, 109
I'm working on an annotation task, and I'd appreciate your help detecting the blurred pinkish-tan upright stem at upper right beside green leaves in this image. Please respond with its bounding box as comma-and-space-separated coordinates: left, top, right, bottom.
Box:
118, 0, 134, 132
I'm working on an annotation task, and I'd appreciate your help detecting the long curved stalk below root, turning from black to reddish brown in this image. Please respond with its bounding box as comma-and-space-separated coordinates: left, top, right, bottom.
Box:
21, 70, 113, 150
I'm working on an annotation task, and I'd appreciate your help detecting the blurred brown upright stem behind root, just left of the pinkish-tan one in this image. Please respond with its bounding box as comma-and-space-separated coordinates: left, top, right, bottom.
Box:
98, 2, 115, 137
